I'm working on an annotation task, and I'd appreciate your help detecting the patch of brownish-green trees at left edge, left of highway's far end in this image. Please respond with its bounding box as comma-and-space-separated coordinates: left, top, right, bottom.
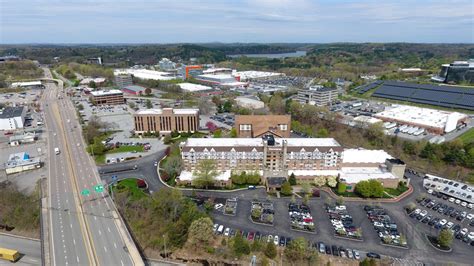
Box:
0, 60, 43, 88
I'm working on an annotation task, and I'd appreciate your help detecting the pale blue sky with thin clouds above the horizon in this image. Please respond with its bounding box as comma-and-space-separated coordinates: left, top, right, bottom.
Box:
0, 0, 474, 44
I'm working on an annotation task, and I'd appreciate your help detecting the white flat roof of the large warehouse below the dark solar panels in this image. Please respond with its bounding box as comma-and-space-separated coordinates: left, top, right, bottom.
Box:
374, 105, 466, 128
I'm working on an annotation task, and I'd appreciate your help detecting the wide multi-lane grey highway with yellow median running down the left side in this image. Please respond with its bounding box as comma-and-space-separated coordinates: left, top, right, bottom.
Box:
43, 69, 143, 265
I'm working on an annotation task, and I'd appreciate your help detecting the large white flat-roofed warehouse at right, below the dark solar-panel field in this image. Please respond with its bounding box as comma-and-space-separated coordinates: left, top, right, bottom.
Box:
374, 105, 468, 134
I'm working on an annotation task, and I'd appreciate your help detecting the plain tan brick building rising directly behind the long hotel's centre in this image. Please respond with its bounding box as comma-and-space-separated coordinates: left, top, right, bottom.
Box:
235, 115, 291, 138
